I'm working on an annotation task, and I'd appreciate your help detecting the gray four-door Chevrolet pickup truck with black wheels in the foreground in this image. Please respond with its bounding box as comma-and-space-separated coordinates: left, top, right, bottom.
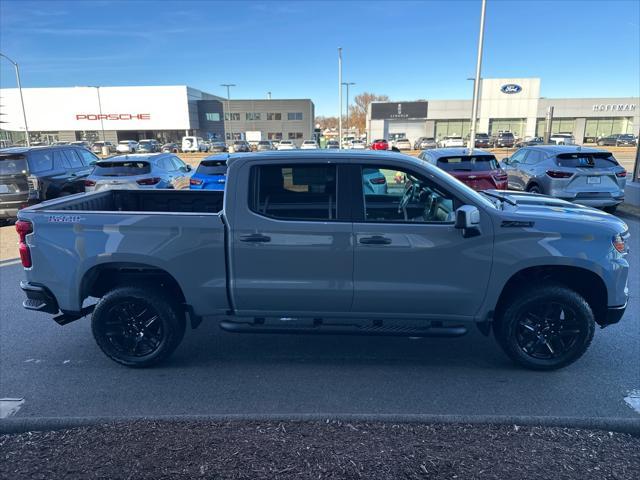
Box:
16, 150, 629, 370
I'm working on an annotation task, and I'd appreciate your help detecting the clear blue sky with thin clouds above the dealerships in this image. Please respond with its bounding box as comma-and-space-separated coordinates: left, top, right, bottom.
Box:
0, 0, 640, 116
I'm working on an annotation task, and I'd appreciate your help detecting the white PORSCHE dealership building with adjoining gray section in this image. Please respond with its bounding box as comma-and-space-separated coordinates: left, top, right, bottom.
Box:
0, 85, 315, 143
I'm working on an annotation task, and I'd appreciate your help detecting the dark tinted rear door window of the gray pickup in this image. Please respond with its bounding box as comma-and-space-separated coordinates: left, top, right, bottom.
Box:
249, 164, 337, 221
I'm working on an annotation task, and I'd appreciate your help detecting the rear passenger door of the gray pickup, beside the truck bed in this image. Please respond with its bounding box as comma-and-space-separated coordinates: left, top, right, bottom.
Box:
230, 160, 353, 317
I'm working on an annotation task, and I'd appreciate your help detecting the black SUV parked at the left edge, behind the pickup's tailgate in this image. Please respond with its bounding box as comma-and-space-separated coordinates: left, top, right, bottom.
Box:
0, 145, 99, 220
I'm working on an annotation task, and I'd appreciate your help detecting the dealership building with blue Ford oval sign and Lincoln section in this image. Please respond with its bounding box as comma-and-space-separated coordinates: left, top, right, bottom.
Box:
367, 78, 640, 143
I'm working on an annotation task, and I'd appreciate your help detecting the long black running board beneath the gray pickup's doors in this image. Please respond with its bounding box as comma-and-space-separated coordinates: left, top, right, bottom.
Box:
220, 320, 467, 337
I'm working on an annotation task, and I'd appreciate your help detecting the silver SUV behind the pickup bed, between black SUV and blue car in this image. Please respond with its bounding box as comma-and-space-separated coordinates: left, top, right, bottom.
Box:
84, 153, 191, 192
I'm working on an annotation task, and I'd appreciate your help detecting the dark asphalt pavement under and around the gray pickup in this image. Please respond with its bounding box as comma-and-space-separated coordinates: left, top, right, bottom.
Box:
0, 212, 640, 418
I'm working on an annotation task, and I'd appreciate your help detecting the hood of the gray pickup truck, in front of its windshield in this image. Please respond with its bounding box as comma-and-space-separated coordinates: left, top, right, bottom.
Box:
490, 190, 628, 233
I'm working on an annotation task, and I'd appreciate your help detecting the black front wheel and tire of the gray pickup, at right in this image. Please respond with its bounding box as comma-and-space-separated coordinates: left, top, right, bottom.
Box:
493, 284, 595, 370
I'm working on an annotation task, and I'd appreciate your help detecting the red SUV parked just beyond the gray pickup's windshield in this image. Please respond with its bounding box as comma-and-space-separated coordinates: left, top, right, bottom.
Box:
419, 148, 507, 191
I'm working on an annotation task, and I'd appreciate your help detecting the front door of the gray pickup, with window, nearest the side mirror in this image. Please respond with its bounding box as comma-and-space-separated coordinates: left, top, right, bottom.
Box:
353, 165, 493, 320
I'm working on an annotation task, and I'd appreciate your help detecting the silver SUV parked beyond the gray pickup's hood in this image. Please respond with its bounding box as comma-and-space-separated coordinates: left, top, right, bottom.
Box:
502, 145, 627, 212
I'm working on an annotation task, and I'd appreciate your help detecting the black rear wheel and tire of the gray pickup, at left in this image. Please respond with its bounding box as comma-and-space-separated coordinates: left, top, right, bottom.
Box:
91, 286, 186, 368
